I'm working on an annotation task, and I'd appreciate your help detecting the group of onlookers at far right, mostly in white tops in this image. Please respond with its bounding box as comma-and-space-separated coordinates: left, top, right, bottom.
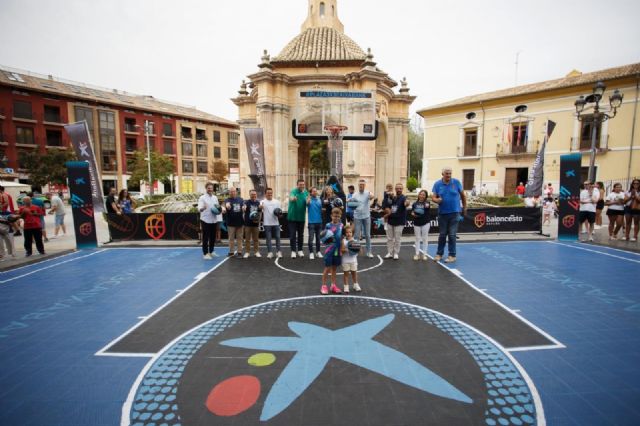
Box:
579, 179, 640, 241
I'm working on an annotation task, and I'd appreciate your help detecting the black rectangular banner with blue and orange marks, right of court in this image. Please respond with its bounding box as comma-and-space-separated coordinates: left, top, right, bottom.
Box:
558, 153, 582, 241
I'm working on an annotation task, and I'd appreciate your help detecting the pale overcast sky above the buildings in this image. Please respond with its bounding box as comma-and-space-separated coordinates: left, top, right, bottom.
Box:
0, 0, 640, 124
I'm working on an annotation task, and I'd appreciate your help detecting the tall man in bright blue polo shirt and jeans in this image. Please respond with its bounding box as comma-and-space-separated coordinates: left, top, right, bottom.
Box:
431, 167, 467, 263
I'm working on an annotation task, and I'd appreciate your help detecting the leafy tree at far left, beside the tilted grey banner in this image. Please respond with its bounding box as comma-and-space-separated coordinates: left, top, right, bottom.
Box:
20, 149, 76, 188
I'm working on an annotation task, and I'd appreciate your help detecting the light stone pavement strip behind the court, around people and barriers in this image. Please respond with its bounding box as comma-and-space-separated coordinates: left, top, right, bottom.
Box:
0, 211, 640, 271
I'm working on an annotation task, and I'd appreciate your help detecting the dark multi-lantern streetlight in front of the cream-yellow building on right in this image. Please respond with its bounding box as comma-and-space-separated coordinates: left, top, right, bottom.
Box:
574, 81, 624, 182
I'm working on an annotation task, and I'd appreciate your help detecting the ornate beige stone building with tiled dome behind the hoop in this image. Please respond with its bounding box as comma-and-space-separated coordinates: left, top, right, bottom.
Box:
233, 0, 415, 196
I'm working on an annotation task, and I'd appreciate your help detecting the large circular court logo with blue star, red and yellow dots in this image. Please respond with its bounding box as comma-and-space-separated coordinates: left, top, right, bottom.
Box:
123, 296, 541, 425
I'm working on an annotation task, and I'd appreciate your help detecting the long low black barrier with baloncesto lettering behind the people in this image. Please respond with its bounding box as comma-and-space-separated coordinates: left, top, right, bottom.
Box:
106, 207, 542, 242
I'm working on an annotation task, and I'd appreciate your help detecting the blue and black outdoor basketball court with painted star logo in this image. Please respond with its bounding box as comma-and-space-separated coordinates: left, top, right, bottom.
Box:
0, 242, 640, 425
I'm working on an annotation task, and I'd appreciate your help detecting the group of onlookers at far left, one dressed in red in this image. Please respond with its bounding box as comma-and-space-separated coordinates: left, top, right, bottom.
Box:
0, 186, 67, 260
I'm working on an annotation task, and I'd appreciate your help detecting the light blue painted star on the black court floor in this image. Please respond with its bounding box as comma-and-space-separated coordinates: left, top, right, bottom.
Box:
220, 314, 473, 421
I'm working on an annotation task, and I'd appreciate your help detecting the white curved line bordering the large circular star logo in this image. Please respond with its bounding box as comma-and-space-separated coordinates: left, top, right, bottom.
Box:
120, 296, 553, 426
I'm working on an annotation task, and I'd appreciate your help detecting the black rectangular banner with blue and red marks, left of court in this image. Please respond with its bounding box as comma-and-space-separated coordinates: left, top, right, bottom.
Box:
65, 161, 98, 248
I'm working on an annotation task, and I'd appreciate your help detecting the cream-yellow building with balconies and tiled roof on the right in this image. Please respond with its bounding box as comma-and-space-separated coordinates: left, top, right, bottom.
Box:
418, 64, 640, 195
